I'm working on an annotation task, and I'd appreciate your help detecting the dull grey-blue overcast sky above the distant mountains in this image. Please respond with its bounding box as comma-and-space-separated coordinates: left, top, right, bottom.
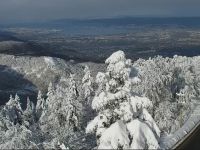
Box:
0, 0, 200, 23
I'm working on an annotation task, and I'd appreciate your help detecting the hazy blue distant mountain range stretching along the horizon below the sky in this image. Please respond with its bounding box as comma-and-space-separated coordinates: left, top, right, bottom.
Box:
0, 17, 200, 28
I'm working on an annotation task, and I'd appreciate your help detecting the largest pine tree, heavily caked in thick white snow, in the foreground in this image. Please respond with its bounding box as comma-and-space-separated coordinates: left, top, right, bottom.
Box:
86, 51, 160, 149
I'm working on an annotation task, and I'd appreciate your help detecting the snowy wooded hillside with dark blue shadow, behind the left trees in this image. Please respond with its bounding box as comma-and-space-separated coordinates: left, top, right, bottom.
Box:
0, 54, 104, 105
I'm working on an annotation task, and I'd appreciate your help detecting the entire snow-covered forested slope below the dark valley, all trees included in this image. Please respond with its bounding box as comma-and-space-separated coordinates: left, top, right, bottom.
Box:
0, 51, 200, 149
